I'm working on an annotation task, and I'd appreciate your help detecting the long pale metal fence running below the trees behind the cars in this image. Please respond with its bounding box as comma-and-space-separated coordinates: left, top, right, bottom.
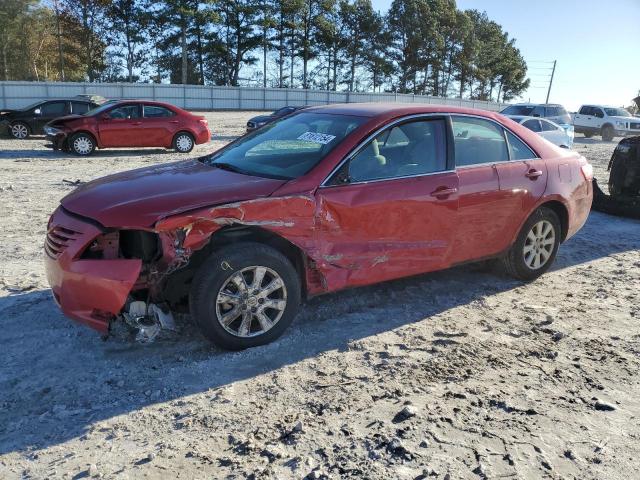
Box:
0, 82, 503, 111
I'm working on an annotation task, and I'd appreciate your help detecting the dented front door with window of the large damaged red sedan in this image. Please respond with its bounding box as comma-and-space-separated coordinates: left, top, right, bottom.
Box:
316, 118, 458, 290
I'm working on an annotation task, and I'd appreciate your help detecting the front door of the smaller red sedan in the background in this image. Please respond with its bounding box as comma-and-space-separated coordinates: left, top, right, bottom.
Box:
98, 103, 142, 147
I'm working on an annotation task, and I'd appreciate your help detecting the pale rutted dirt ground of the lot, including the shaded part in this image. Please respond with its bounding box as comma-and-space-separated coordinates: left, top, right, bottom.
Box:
0, 112, 640, 480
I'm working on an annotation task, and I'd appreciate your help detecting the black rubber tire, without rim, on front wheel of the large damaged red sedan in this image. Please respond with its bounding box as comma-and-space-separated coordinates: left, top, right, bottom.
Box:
189, 242, 301, 350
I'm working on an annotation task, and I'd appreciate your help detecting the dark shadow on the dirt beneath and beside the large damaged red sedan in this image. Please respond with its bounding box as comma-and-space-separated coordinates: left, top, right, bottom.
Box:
0, 213, 640, 454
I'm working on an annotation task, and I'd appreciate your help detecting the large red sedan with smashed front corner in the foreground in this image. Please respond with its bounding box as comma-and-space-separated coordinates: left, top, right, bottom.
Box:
45, 104, 592, 349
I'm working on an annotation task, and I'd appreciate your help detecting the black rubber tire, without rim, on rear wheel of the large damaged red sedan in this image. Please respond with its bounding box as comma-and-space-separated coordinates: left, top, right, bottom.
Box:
502, 207, 562, 281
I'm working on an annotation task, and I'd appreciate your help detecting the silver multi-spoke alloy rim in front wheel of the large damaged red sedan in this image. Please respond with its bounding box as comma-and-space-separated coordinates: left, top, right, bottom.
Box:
216, 266, 287, 338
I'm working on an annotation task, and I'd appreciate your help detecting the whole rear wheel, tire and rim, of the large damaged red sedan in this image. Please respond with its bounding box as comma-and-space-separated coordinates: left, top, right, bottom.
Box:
503, 207, 561, 281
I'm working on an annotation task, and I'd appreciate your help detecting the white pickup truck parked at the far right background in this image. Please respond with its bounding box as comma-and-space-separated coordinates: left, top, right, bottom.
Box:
573, 105, 640, 141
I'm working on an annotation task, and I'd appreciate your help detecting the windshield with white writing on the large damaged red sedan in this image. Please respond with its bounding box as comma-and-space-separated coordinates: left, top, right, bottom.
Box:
205, 113, 367, 180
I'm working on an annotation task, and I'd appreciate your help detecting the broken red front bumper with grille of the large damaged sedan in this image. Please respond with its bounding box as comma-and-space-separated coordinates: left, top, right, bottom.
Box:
44, 207, 142, 334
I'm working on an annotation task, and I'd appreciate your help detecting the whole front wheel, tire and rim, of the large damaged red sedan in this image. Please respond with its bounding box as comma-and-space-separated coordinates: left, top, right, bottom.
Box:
189, 242, 300, 350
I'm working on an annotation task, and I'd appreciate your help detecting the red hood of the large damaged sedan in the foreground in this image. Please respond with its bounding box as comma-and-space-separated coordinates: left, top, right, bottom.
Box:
61, 160, 286, 228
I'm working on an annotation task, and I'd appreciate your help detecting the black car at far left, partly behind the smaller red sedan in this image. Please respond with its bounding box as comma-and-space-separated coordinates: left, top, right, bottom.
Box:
0, 95, 99, 139
